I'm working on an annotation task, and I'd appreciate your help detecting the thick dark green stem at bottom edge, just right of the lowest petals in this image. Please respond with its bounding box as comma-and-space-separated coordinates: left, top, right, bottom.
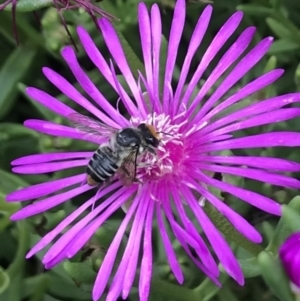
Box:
151, 279, 200, 301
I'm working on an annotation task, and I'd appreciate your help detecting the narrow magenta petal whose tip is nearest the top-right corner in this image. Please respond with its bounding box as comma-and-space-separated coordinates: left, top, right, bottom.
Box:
194, 37, 273, 122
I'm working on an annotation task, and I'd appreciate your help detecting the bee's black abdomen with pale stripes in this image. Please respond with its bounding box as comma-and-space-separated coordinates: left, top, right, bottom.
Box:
86, 146, 120, 186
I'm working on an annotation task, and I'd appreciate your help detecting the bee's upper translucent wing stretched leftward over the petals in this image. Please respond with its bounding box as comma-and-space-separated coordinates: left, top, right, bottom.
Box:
68, 113, 118, 139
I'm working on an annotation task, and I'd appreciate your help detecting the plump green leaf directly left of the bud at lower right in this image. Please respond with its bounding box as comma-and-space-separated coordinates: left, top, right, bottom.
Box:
257, 251, 294, 301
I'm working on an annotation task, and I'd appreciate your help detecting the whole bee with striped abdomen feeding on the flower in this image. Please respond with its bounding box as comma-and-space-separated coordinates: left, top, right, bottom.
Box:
68, 113, 160, 186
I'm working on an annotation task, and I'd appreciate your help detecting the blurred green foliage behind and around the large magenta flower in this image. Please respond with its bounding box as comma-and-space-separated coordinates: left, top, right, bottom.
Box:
0, 0, 300, 301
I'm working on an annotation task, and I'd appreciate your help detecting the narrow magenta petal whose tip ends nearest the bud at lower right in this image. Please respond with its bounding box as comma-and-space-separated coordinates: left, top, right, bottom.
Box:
184, 177, 262, 243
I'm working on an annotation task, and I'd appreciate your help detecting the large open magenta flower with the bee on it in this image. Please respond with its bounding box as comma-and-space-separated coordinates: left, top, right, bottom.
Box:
7, 0, 300, 300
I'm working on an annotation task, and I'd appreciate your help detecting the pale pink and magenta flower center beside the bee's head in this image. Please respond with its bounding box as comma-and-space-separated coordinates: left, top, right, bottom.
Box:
131, 114, 185, 183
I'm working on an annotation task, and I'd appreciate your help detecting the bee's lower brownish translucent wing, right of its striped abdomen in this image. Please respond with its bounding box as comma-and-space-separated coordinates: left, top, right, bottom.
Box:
118, 149, 138, 185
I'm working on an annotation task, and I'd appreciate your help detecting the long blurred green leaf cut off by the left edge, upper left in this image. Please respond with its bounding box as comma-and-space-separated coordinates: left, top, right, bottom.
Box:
0, 46, 36, 118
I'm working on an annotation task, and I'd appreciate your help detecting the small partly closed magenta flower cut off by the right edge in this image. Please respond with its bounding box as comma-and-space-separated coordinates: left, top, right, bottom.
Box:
279, 232, 300, 289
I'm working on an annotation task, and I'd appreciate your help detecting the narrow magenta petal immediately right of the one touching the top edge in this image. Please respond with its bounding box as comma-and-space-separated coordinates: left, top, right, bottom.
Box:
172, 5, 212, 115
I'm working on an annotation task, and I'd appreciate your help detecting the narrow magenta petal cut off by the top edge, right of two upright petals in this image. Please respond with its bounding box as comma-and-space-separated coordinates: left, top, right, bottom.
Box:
163, 0, 185, 113
